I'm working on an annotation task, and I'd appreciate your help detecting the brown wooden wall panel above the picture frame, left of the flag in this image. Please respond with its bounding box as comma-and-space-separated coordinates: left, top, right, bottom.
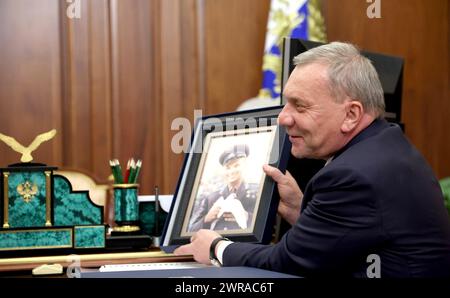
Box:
204, 0, 270, 114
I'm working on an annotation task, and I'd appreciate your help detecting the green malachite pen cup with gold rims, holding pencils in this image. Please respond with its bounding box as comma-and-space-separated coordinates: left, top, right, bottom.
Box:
113, 184, 140, 232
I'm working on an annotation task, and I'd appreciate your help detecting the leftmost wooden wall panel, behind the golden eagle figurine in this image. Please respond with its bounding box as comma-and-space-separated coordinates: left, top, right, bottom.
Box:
0, 0, 62, 166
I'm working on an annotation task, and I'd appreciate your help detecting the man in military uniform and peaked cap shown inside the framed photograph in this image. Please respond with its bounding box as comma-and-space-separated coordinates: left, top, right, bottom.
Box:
188, 144, 258, 232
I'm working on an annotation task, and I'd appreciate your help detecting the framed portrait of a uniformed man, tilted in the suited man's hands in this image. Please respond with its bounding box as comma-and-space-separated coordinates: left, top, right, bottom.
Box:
161, 106, 290, 251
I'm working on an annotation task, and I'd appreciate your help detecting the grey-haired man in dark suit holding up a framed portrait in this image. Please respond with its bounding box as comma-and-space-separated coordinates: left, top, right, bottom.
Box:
176, 42, 450, 277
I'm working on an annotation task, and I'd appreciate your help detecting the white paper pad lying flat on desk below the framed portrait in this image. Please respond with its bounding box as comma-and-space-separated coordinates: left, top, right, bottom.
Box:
99, 262, 211, 272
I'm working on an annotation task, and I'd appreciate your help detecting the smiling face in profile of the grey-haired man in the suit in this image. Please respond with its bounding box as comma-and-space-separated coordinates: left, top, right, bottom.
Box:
278, 63, 346, 159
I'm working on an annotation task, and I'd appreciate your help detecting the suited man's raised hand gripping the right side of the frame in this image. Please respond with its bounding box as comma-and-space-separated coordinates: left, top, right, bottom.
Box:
263, 165, 303, 225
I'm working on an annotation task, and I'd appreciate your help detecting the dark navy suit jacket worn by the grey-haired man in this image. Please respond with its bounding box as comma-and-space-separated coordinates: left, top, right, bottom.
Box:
223, 120, 450, 277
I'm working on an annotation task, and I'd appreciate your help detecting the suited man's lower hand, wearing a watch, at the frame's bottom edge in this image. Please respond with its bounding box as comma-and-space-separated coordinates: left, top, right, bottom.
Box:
173, 229, 220, 265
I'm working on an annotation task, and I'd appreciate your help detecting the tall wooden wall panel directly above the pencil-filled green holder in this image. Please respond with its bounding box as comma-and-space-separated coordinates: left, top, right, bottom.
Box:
111, 0, 159, 193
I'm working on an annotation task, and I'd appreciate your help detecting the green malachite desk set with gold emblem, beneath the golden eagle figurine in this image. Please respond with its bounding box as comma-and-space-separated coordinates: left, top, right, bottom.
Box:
0, 163, 106, 252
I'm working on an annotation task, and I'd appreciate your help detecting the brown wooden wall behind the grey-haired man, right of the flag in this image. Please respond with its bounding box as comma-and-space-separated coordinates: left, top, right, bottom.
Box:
325, 0, 450, 177
